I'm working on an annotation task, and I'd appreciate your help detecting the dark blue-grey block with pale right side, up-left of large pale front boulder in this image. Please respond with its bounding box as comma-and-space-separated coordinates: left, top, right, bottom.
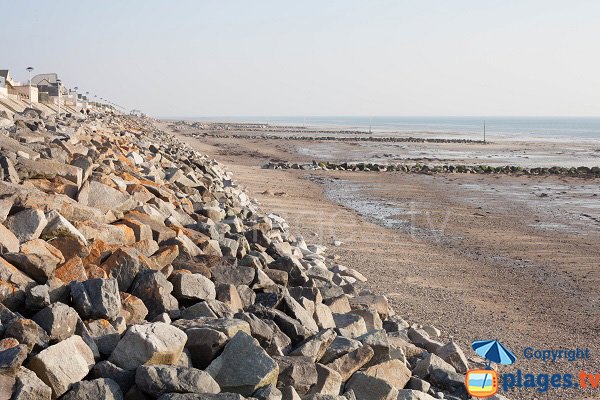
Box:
70, 278, 121, 320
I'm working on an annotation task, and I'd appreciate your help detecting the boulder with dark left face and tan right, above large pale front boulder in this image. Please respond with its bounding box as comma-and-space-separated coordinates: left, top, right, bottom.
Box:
131, 270, 179, 320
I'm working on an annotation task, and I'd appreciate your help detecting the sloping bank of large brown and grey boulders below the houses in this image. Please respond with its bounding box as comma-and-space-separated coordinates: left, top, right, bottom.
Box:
0, 113, 506, 400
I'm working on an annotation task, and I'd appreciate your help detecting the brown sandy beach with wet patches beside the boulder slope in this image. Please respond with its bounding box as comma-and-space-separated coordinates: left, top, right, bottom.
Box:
161, 122, 600, 398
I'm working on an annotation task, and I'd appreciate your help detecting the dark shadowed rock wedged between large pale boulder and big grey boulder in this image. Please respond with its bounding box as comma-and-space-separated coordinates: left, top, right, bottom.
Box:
185, 328, 229, 369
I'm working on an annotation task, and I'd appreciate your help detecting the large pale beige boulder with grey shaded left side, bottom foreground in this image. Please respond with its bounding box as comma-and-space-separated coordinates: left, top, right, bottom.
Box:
108, 322, 187, 370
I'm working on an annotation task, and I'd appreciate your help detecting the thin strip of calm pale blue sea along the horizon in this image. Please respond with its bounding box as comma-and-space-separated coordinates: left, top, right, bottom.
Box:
188, 116, 600, 140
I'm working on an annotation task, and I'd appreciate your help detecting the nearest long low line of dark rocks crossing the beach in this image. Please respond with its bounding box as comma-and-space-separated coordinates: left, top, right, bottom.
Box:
262, 161, 600, 178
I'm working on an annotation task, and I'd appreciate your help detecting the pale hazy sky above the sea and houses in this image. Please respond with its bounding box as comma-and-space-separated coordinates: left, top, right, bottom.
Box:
0, 0, 600, 116
